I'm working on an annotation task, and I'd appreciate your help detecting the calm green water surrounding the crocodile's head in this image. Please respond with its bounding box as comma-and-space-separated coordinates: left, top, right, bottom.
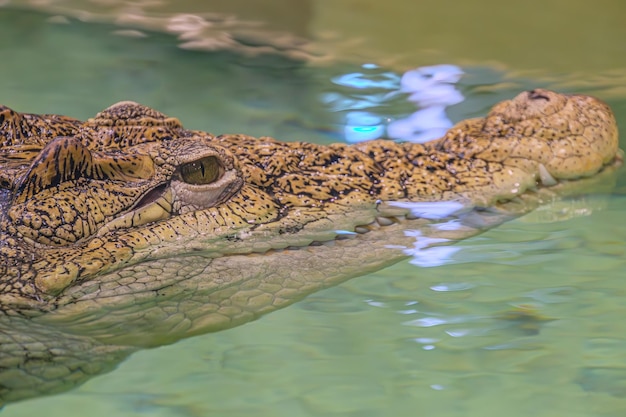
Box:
0, 1, 626, 417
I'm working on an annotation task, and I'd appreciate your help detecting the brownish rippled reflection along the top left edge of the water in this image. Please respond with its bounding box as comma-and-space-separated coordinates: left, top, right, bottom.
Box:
6, 0, 313, 60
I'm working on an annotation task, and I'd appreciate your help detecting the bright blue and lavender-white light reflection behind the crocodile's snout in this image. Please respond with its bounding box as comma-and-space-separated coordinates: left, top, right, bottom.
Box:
321, 64, 464, 143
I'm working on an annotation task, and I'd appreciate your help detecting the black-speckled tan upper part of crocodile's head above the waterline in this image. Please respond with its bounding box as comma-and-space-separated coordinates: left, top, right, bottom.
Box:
0, 90, 618, 313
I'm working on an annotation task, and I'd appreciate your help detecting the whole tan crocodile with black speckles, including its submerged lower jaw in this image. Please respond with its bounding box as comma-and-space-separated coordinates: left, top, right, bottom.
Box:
0, 89, 622, 400
